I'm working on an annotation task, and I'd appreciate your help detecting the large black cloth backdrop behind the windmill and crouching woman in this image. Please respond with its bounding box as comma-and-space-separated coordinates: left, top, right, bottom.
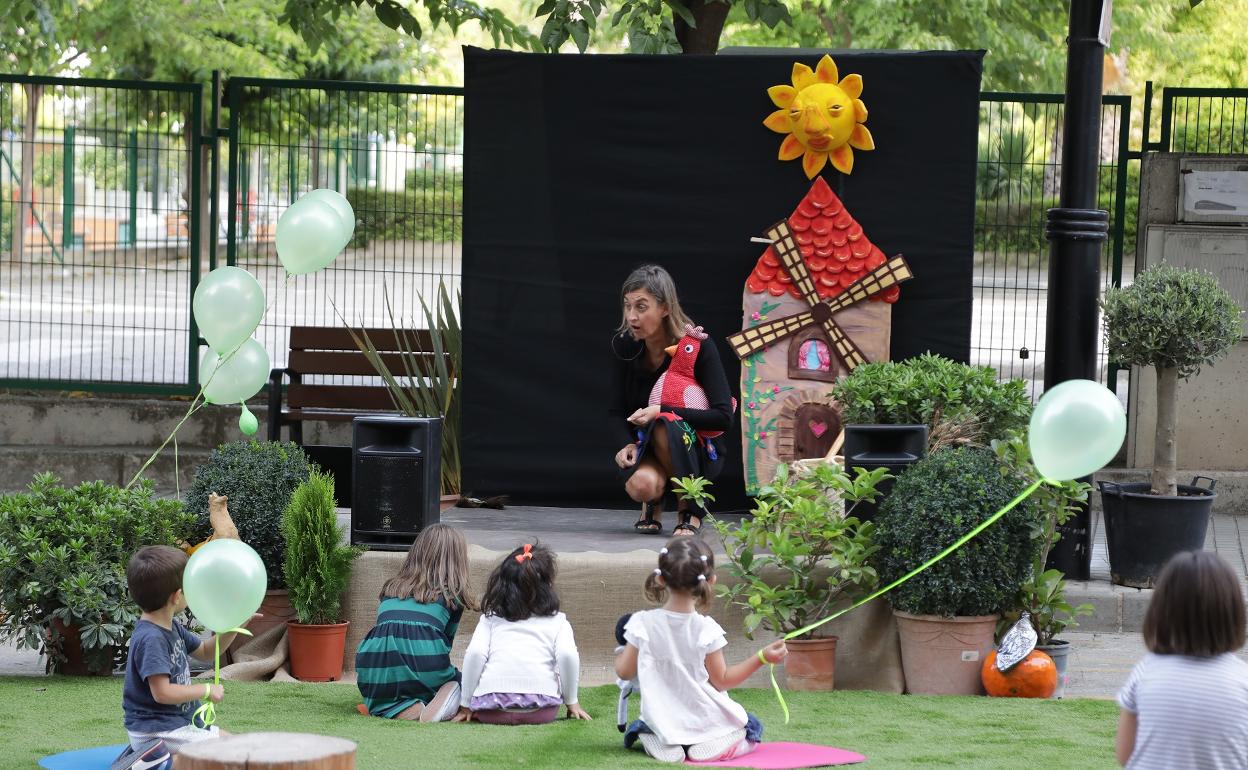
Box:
461, 49, 982, 509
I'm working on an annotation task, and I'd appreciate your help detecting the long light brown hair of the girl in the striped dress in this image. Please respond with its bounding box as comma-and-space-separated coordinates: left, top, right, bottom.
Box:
378, 524, 477, 609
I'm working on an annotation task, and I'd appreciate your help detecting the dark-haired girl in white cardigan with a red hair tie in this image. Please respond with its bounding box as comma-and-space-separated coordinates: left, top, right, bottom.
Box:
456, 543, 590, 725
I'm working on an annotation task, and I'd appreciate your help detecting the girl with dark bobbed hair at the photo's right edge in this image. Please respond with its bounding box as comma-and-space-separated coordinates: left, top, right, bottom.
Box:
1114, 550, 1248, 770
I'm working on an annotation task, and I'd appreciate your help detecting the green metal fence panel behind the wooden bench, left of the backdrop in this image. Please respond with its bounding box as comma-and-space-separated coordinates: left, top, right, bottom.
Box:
223, 77, 463, 376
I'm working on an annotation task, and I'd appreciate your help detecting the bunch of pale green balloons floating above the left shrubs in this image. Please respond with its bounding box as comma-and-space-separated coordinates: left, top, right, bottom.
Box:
191, 190, 356, 436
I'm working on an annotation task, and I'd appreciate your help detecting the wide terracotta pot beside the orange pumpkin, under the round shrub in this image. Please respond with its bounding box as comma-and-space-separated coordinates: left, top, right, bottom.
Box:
892, 609, 998, 695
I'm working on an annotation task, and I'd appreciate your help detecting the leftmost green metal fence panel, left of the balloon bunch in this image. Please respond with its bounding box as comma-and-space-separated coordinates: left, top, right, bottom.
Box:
0, 75, 202, 392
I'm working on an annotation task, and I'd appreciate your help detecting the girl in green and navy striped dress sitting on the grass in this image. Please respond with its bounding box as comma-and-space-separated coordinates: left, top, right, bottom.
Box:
356, 524, 475, 721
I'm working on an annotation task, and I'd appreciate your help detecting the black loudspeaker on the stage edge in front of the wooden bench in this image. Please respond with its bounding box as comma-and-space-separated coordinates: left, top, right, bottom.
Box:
351, 416, 442, 550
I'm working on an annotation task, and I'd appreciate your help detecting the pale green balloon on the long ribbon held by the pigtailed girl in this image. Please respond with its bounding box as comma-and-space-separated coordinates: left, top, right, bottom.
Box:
1027, 379, 1127, 482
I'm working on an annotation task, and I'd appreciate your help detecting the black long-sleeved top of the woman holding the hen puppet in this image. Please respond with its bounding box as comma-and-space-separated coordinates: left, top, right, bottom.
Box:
607, 332, 733, 448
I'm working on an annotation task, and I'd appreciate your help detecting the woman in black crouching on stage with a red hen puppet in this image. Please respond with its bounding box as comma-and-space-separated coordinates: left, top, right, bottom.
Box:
608, 265, 734, 535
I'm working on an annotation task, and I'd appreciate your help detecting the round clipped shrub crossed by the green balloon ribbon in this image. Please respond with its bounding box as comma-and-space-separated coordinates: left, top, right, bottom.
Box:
875, 447, 1038, 618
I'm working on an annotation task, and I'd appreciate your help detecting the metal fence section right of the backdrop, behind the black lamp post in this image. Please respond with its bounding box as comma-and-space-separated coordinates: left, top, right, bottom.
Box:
971, 92, 1138, 397
